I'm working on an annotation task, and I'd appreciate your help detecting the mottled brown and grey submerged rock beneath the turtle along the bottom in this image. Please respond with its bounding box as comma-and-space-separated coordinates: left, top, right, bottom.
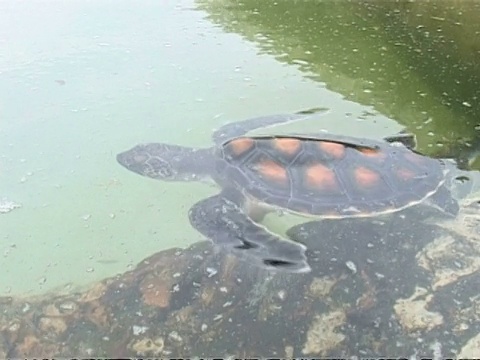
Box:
0, 193, 480, 359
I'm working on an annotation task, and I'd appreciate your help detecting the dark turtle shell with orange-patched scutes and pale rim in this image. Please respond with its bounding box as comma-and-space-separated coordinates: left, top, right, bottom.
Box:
216, 136, 445, 218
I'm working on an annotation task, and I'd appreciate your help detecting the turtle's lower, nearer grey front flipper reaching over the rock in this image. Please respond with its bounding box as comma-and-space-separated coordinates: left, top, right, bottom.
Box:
189, 191, 310, 273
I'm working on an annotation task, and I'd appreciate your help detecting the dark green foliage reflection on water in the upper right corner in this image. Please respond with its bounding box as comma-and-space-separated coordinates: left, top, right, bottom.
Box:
198, 0, 480, 162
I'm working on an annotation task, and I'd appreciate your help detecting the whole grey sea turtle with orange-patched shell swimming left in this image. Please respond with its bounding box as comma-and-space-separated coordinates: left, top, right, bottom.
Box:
117, 111, 459, 273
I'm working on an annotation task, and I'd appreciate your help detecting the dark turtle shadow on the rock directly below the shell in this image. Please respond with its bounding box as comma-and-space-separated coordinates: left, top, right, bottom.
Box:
287, 213, 439, 293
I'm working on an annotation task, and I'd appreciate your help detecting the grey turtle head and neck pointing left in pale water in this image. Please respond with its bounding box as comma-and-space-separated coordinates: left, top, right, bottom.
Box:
117, 143, 212, 181
